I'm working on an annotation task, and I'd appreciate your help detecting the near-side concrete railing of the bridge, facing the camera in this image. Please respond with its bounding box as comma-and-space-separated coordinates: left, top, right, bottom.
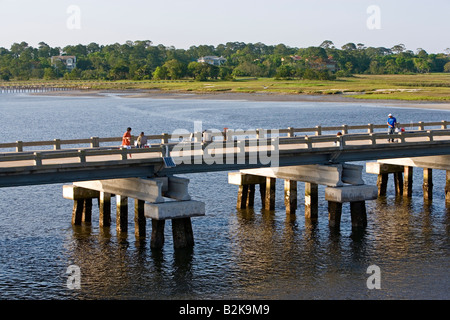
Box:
0, 129, 450, 167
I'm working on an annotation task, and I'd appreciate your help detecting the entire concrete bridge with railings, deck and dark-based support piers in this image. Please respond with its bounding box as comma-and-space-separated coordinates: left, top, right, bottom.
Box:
0, 121, 450, 247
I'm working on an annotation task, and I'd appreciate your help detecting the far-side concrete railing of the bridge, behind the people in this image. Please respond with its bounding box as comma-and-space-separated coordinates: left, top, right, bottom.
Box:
0, 120, 450, 152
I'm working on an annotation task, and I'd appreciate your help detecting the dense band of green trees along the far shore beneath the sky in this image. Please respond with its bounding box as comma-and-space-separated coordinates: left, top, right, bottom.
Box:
0, 40, 450, 81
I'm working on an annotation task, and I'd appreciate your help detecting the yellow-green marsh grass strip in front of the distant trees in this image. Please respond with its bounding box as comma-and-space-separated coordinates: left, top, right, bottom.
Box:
0, 73, 450, 102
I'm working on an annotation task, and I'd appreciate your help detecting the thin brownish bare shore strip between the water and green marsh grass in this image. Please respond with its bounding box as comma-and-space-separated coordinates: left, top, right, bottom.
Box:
30, 90, 450, 110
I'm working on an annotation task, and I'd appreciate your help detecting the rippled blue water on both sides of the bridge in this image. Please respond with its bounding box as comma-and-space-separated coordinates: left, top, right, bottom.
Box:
0, 94, 450, 300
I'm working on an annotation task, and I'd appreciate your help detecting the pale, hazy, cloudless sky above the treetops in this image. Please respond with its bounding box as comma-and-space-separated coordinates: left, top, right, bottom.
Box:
0, 0, 450, 53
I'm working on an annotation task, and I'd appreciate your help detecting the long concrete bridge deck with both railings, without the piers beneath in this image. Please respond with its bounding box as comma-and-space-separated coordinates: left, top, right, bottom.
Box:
0, 121, 450, 187
